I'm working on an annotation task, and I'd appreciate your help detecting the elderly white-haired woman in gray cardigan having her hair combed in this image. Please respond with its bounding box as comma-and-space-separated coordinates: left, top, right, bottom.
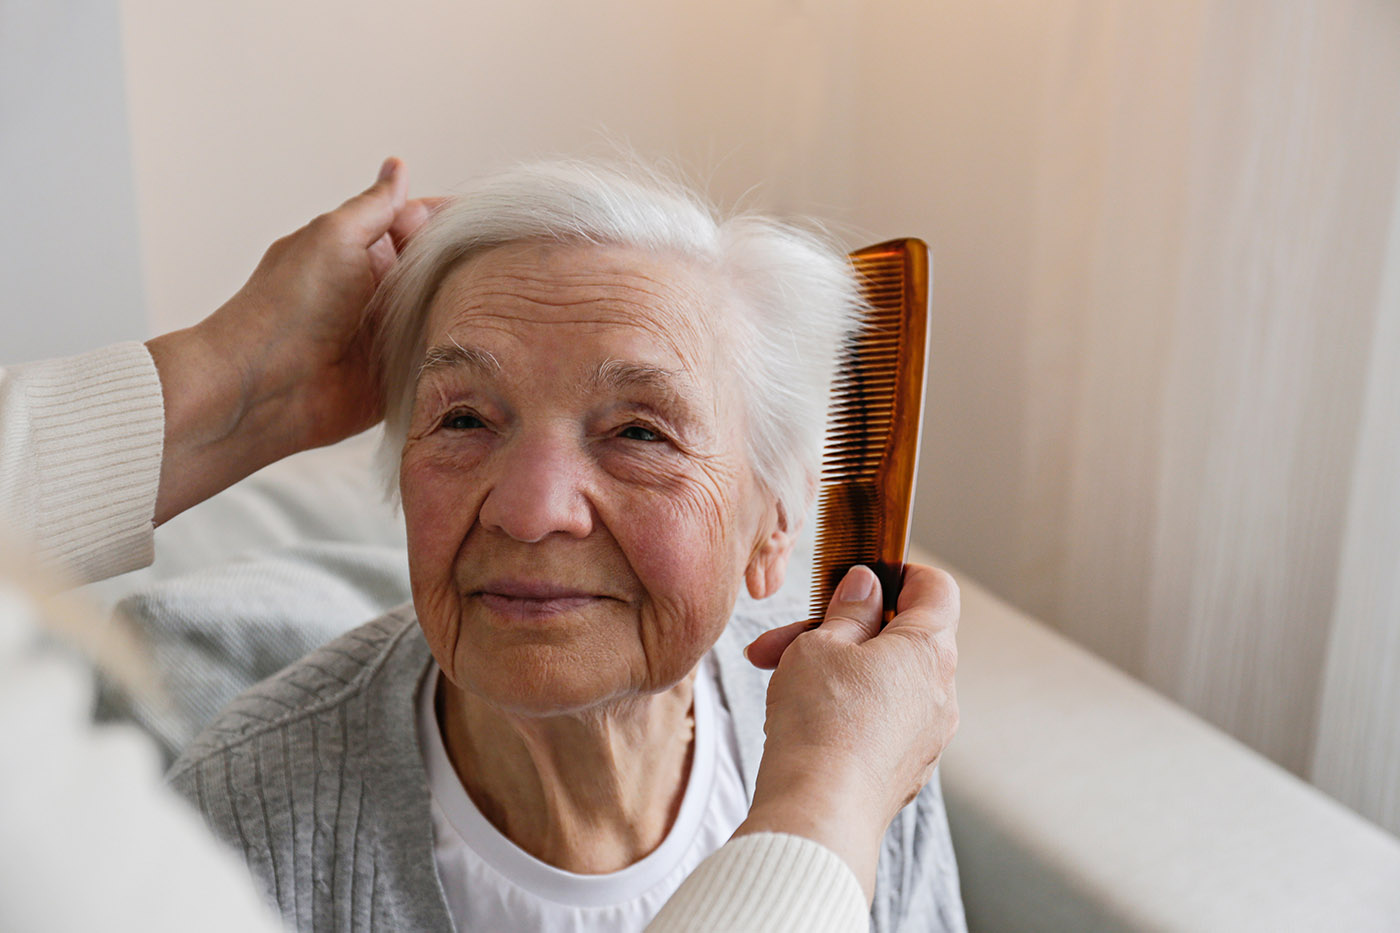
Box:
171, 163, 962, 930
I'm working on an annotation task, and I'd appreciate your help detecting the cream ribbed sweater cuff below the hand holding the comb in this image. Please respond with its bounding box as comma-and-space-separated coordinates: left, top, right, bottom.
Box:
647, 832, 869, 933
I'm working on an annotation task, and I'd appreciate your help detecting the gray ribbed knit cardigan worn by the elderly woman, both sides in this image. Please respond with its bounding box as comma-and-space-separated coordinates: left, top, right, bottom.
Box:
169, 598, 966, 933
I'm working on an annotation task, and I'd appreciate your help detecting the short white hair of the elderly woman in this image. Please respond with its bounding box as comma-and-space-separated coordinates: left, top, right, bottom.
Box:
375, 161, 862, 531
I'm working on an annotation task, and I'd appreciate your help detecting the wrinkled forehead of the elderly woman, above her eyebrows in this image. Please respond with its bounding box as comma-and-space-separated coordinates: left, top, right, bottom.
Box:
427, 242, 721, 375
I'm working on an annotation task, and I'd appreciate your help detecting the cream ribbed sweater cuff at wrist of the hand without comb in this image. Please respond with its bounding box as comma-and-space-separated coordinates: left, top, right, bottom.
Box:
17, 337, 165, 581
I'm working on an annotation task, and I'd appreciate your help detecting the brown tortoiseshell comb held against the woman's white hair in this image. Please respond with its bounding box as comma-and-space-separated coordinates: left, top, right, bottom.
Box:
811, 240, 928, 626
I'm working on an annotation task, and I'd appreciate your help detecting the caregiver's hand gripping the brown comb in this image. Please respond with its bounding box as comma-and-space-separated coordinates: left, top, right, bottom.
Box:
735, 565, 958, 899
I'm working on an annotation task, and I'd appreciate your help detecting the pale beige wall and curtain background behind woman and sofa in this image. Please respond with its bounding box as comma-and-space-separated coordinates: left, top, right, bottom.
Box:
8, 0, 1400, 834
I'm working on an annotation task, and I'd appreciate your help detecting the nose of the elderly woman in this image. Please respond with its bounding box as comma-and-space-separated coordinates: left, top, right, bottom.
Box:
480, 438, 592, 542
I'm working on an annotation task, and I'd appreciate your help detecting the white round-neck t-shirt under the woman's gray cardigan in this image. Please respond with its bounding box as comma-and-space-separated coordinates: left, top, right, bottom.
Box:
417, 657, 749, 933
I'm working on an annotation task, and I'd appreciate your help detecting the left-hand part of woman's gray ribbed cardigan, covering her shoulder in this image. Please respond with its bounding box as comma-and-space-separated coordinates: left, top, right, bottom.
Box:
169, 605, 441, 929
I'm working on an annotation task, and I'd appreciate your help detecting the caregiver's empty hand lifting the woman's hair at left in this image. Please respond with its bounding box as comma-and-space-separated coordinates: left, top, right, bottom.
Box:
146, 158, 433, 524
